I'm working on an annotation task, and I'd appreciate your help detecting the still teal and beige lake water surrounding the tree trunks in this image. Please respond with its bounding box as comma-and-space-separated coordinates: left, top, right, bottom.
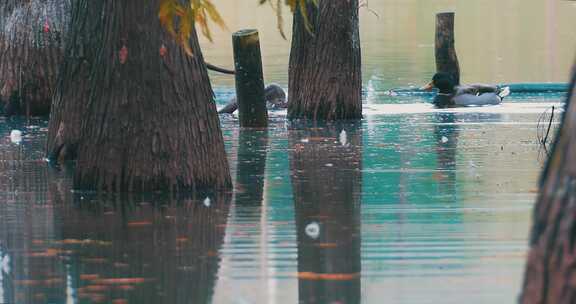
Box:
0, 0, 576, 304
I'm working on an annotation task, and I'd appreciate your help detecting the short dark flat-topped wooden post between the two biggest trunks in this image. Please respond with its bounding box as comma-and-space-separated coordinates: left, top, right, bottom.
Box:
232, 29, 268, 128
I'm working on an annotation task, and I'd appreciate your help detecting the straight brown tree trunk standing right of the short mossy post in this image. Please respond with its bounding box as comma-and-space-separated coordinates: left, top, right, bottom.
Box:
288, 0, 362, 120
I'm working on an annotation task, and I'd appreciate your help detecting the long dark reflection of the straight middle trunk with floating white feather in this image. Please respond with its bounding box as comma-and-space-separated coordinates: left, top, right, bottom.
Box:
290, 121, 362, 303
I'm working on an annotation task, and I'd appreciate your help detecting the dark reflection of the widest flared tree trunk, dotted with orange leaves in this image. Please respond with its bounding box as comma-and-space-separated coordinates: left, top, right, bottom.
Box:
54, 191, 230, 304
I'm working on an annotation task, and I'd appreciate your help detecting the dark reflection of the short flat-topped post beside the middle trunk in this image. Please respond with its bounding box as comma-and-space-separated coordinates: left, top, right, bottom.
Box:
235, 128, 268, 206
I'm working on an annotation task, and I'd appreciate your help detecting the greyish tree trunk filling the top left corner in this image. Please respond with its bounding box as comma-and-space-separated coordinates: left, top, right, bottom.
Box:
0, 0, 70, 115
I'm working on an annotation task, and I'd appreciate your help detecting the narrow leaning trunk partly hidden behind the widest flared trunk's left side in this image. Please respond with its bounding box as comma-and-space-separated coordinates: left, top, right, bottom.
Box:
46, 0, 106, 160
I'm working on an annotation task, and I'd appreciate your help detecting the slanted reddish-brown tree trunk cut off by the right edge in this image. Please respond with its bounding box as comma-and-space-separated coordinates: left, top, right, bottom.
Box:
521, 63, 576, 304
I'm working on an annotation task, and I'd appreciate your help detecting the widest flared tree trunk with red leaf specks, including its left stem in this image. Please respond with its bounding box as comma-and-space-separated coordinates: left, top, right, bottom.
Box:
48, 0, 231, 192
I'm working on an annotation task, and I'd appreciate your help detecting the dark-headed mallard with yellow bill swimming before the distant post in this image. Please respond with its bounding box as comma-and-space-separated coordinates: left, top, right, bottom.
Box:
422, 72, 510, 108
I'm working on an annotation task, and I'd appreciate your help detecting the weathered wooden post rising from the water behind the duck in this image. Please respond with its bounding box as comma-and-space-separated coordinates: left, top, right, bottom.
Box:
435, 13, 460, 84
